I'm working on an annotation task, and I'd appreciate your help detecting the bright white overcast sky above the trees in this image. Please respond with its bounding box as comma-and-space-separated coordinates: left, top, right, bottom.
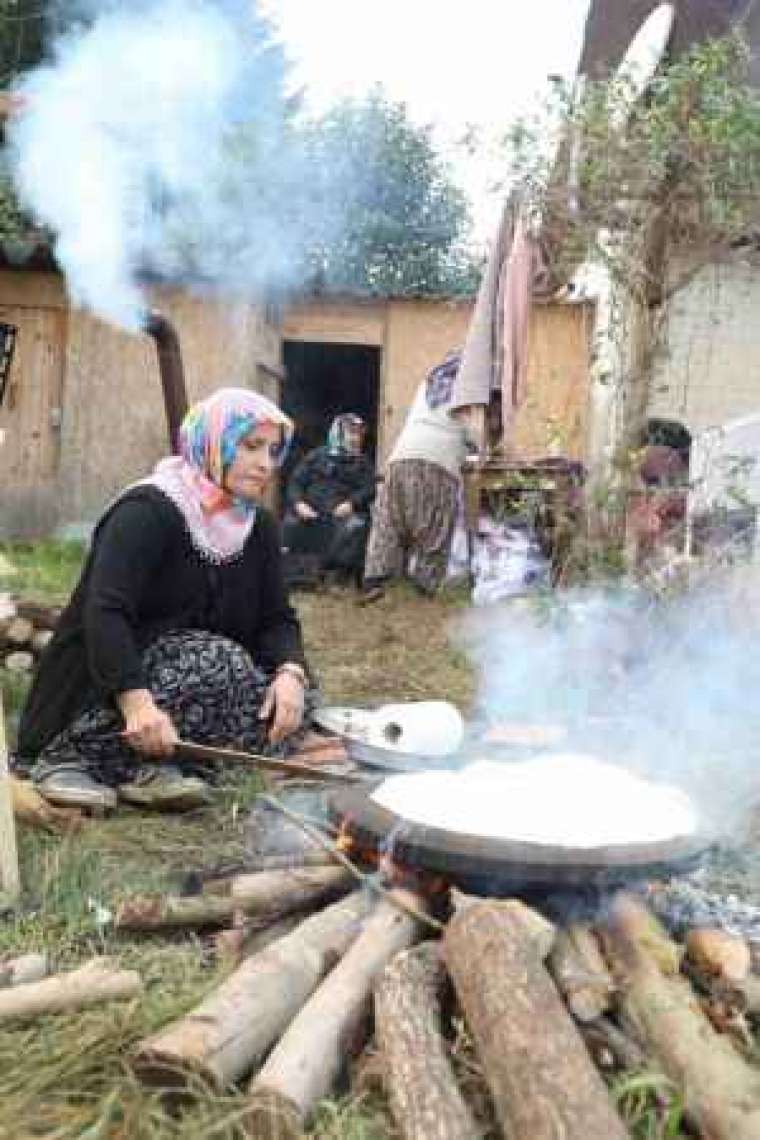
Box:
261, 0, 589, 233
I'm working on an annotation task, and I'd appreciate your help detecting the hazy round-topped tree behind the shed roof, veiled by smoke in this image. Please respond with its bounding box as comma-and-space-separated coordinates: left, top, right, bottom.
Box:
307, 91, 476, 295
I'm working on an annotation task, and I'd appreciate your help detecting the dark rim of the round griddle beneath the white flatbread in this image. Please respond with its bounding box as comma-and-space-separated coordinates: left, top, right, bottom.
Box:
328, 788, 711, 895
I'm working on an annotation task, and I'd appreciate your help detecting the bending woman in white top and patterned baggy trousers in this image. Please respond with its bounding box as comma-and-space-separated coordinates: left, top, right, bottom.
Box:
363, 352, 469, 602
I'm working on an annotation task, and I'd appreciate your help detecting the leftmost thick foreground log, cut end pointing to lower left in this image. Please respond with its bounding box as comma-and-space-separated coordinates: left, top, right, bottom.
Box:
132, 891, 370, 1091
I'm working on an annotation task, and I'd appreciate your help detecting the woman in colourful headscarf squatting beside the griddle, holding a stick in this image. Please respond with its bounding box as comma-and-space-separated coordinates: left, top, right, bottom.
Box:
18, 388, 307, 807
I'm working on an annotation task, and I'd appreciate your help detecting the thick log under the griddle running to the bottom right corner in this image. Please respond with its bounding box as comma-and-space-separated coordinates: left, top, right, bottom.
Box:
604, 897, 760, 1140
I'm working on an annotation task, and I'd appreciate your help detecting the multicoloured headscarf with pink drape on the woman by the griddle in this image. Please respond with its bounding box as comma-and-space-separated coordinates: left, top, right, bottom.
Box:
140, 388, 293, 562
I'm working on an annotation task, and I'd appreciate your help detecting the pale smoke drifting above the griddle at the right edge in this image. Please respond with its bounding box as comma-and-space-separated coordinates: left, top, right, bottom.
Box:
464, 568, 760, 838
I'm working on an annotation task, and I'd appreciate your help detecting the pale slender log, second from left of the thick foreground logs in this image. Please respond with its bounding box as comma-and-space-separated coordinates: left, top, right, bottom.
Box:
247, 890, 425, 1140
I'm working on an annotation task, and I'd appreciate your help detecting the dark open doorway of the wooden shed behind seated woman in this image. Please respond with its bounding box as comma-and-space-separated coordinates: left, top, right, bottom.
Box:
283, 341, 381, 486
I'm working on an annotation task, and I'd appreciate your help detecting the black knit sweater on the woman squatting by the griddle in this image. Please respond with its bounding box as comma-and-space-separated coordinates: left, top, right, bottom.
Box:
18, 487, 304, 758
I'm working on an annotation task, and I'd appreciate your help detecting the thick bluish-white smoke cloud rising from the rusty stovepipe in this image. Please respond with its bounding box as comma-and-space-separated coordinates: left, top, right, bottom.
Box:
10, 0, 348, 329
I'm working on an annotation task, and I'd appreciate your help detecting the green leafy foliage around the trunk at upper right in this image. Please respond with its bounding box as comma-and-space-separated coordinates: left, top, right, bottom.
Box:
506, 35, 760, 299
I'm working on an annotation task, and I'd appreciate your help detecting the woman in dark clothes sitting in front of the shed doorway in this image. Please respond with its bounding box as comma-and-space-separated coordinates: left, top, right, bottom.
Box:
283, 413, 375, 580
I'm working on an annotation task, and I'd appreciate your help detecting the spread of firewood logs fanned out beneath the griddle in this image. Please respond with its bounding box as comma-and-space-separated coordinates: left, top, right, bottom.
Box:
109, 834, 760, 1140
